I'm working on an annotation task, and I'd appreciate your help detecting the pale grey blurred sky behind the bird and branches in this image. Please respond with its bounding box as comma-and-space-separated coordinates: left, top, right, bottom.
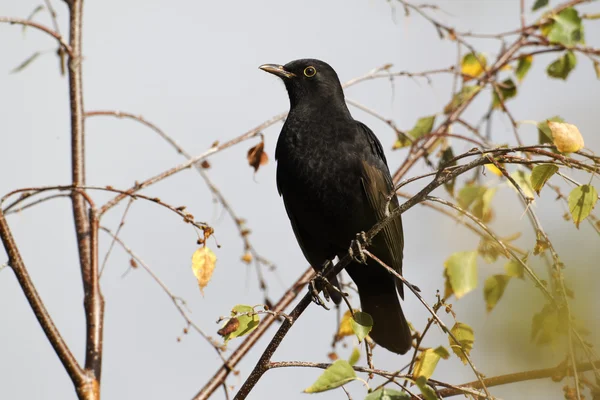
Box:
0, 0, 600, 399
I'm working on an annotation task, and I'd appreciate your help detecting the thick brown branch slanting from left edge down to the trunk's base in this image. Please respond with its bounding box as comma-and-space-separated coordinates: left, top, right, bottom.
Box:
0, 209, 91, 398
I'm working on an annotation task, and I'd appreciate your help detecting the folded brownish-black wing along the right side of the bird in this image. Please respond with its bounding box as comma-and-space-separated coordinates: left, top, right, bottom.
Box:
360, 124, 404, 298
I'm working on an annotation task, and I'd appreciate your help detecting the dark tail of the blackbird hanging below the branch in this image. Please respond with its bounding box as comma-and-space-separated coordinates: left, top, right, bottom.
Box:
358, 284, 412, 354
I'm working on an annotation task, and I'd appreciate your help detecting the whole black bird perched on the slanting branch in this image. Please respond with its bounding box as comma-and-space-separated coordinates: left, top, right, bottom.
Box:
260, 59, 412, 354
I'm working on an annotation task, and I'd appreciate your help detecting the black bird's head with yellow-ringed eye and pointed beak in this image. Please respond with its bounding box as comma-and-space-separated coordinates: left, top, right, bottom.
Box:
259, 58, 345, 108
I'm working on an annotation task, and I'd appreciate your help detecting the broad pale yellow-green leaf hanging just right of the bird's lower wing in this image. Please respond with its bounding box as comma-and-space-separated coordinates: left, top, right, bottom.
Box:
444, 251, 477, 299
